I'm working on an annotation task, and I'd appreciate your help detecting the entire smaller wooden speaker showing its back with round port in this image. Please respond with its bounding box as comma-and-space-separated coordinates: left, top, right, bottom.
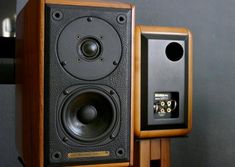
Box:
134, 26, 192, 138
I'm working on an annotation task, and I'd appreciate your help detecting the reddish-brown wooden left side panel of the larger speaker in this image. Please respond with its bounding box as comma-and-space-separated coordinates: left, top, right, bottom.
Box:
16, 0, 44, 167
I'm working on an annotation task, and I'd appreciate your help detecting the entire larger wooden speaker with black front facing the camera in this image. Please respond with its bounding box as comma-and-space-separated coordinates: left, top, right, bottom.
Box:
16, 0, 135, 167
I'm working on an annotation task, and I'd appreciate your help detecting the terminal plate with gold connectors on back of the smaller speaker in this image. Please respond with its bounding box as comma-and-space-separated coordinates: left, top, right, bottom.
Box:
153, 92, 179, 119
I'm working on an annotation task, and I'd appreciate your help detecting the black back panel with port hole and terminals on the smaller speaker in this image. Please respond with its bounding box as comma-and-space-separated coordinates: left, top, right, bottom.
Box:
141, 34, 188, 130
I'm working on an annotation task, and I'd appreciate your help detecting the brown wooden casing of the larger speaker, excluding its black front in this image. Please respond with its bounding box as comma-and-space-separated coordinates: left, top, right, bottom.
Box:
16, 0, 135, 167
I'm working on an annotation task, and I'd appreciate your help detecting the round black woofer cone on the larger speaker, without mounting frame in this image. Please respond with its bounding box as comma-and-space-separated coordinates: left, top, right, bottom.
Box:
62, 89, 119, 144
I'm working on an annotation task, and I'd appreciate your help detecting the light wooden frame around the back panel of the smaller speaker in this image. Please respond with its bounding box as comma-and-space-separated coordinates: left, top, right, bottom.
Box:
134, 25, 193, 138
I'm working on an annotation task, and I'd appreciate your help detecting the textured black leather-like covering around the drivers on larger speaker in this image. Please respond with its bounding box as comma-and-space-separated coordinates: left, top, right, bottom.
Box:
44, 5, 131, 166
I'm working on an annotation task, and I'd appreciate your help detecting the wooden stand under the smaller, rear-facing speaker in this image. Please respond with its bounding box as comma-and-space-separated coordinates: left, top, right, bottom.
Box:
134, 138, 170, 167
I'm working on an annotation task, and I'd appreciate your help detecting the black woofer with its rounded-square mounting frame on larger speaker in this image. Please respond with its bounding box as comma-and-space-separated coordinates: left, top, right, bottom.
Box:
58, 85, 120, 145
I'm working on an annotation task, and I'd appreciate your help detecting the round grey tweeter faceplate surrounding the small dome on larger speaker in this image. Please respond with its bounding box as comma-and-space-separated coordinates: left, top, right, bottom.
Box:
57, 17, 122, 80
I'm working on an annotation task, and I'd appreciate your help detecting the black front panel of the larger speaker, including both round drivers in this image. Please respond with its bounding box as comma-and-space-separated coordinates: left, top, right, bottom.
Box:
44, 4, 132, 166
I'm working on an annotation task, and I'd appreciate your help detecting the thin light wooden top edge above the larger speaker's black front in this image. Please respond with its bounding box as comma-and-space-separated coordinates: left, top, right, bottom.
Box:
46, 0, 132, 9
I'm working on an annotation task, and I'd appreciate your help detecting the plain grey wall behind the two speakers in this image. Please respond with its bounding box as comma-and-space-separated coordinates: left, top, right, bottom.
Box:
0, 0, 235, 167
